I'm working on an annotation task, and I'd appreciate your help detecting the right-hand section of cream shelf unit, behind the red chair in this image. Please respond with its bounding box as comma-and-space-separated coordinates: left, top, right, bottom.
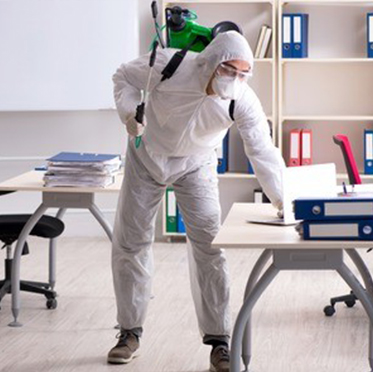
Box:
277, 0, 373, 181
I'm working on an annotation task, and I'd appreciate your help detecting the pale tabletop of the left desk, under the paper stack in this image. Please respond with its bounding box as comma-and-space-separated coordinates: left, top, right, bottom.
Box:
0, 171, 123, 193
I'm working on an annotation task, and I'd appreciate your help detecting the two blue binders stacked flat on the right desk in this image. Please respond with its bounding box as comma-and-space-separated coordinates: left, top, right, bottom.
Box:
294, 193, 373, 240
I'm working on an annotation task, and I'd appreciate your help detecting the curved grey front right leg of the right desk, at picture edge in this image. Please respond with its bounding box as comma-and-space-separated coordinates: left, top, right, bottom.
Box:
337, 264, 373, 372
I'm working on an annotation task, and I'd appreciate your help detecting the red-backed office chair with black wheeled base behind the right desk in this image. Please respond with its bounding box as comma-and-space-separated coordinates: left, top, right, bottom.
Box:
324, 134, 361, 316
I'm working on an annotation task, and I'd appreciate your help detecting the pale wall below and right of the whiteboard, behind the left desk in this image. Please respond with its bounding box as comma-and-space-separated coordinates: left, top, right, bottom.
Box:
0, 1, 257, 238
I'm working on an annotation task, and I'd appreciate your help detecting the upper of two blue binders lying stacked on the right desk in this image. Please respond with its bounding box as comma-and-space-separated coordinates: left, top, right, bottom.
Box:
294, 196, 373, 221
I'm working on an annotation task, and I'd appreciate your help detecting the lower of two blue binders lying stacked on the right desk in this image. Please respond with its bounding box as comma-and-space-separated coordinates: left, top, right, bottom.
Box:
302, 219, 373, 240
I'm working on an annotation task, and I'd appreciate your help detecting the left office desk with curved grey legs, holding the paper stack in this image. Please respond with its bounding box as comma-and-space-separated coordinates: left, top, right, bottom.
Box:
0, 171, 123, 327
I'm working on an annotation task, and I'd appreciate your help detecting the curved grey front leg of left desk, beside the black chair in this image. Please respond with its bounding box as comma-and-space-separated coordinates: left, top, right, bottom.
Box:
9, 203, 48, 327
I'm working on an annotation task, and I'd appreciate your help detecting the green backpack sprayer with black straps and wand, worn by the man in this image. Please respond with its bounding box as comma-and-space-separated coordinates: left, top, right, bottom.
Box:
135, 0, 242, 148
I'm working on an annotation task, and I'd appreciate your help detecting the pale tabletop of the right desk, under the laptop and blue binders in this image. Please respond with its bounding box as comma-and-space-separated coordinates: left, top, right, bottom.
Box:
212, 203, 373, 249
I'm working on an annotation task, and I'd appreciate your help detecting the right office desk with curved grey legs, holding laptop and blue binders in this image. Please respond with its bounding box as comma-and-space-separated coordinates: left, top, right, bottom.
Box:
212, 203, 373, 372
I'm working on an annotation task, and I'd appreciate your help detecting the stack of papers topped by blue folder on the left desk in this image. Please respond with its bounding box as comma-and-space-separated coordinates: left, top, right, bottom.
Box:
44, 152, 121, 187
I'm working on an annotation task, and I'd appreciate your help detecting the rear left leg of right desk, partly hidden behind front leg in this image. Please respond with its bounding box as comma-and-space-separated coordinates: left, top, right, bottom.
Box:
242, 249, 273, 371
